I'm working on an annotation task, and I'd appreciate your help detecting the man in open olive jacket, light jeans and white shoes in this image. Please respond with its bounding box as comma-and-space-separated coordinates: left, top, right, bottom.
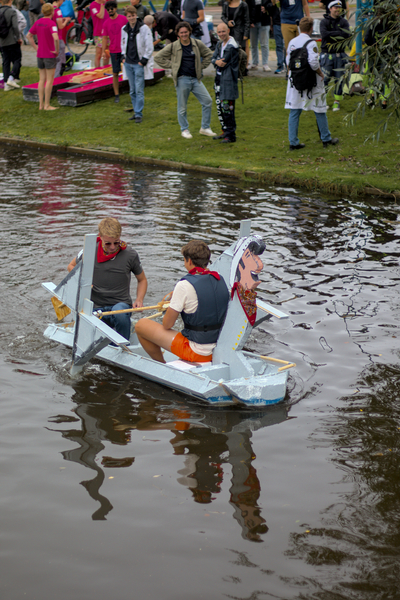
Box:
154, 21, 216, 140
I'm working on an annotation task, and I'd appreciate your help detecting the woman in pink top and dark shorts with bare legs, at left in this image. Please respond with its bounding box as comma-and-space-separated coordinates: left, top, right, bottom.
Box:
28, 4, 60, 110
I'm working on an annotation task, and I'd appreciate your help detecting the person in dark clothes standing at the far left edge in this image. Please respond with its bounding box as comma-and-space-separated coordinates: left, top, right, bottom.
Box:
0, 0, 22, 92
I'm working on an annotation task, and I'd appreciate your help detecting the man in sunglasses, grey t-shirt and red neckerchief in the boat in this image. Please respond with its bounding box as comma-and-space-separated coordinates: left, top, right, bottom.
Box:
68, 217, 147, 340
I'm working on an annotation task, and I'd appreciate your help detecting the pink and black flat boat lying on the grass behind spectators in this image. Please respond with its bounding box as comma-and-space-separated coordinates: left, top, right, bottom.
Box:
22, 68, 165, 106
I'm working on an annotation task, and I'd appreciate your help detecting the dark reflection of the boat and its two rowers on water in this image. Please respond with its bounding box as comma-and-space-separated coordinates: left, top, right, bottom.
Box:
49, 370, 287, 541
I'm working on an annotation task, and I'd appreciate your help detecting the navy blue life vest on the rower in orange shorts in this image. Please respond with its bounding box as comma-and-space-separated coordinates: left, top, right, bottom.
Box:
181, 274, 229, 344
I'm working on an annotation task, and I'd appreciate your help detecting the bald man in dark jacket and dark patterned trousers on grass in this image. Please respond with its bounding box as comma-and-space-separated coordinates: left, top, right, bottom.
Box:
211, 23, 239, 144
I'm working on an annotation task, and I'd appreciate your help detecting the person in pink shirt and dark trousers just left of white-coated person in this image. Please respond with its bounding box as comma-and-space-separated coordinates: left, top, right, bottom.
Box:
103, 0, 128, 103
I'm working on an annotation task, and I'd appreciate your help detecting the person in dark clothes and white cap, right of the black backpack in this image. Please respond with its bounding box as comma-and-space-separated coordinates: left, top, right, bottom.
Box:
320, 0, 351, 112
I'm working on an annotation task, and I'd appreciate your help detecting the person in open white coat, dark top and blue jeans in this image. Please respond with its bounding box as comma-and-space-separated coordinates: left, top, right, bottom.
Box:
121, 6, 154, 123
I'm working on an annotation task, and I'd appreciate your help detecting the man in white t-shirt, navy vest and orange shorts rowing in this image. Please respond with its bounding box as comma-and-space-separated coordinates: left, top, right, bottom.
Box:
135, 240, 229, 363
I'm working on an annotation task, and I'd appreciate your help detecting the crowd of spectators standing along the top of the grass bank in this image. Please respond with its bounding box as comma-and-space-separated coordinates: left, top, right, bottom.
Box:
0, 0, 360, 147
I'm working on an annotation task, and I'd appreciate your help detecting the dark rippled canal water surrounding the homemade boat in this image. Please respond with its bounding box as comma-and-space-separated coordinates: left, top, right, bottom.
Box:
0, 149, 400, 600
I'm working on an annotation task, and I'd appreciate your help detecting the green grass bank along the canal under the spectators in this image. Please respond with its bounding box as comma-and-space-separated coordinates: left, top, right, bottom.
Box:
0, 67, 400, 195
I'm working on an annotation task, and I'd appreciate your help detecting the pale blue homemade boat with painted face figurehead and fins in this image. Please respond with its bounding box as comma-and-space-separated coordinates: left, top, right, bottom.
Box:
42, 221, 296, 407
